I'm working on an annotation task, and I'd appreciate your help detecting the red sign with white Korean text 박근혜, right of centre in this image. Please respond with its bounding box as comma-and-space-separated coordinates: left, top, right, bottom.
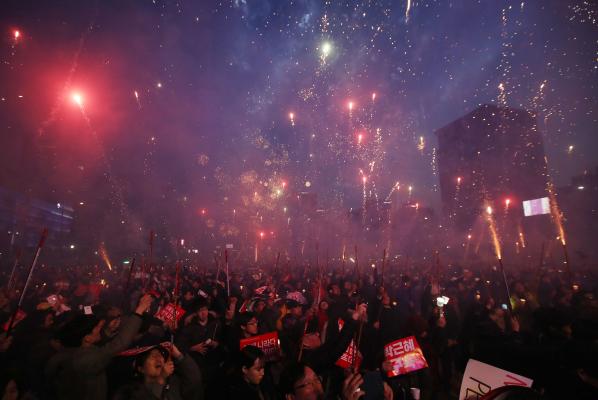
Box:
384, 336, 428, 377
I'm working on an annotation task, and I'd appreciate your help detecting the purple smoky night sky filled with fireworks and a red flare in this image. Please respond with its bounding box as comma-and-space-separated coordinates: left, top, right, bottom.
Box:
0, 0, 598, 253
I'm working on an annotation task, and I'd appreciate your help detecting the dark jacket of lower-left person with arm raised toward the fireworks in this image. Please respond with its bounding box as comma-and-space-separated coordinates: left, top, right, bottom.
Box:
45, 314, 141, 400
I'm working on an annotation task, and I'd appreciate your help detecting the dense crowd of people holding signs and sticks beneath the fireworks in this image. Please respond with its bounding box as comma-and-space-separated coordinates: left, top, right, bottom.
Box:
0, 253, 598, 400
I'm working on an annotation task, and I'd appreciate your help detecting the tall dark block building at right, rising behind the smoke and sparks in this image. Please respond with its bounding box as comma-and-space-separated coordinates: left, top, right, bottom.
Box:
435, 104, 547, 232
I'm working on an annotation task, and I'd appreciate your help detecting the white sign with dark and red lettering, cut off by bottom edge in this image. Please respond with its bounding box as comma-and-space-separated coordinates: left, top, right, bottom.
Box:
459, 359, 534, 400
